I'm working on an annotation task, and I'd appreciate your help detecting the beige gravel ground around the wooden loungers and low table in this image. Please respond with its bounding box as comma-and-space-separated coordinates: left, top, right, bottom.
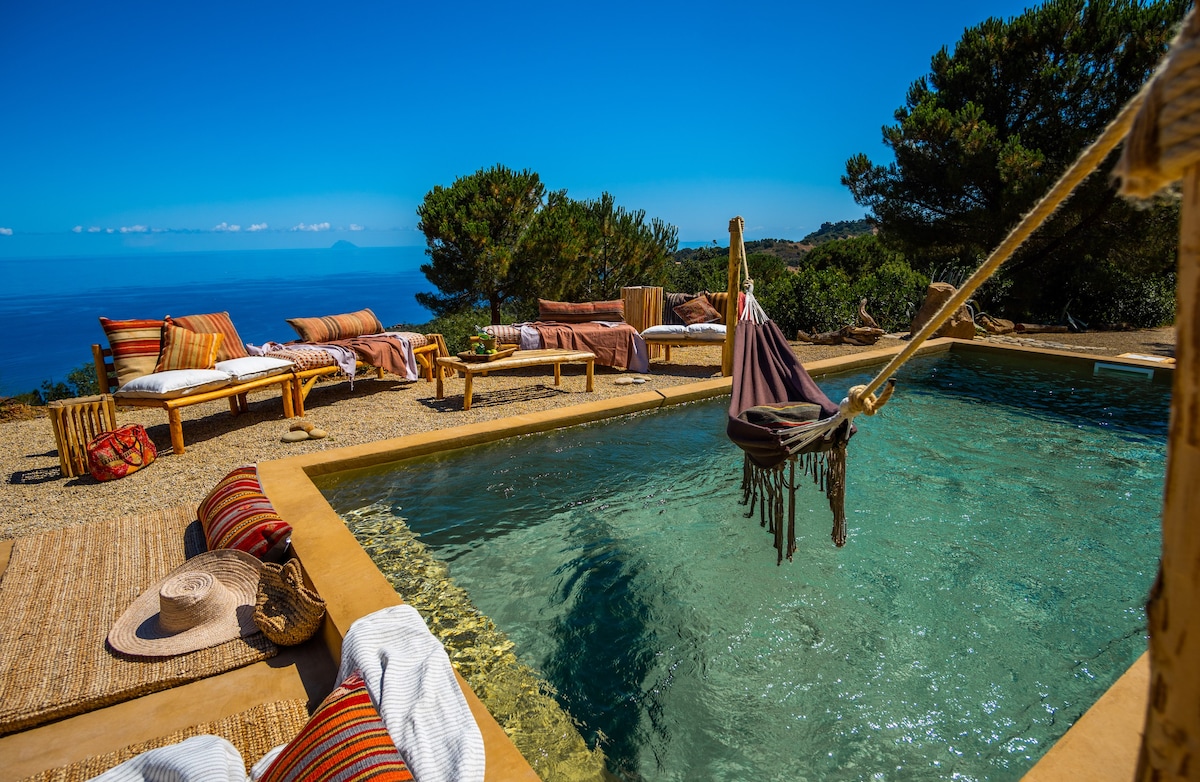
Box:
0, 329, 1175, 539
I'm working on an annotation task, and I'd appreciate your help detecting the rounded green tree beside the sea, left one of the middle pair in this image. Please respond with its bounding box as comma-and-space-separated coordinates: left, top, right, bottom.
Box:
416, 166, 546, 323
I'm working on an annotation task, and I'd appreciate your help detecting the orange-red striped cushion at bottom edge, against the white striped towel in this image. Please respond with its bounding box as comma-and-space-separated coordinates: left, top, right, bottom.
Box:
259, 673, 413, 782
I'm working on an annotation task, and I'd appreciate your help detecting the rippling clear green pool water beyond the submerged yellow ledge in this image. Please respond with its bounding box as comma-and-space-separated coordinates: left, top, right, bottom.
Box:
322, 354, 1170, 781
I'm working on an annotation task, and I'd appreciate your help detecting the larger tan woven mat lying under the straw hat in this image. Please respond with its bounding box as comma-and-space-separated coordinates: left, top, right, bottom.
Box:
0, 507, 278, 735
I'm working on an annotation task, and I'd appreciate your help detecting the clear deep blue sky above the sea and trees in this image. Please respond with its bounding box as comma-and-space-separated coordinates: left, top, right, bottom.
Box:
0, 0, 1033, 258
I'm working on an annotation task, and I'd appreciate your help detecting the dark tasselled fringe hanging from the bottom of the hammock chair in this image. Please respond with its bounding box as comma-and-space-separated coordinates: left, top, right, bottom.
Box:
742, 441, 846, 565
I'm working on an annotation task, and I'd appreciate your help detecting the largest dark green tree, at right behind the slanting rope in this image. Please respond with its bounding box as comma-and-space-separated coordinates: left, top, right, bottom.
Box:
842, 0, 1190, 325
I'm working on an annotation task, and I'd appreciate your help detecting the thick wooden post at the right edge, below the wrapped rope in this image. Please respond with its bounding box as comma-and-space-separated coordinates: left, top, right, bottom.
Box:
1135, 166, 1200, 782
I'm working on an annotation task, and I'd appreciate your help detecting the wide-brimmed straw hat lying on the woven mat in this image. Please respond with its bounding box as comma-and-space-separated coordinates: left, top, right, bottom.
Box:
108, 548, 263, 657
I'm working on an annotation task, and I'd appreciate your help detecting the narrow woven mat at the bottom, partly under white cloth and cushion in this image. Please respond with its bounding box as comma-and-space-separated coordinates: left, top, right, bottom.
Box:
23, 699, 308, 782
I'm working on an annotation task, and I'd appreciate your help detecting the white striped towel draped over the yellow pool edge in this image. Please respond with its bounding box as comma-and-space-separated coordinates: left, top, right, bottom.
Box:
337, 606, 485, 782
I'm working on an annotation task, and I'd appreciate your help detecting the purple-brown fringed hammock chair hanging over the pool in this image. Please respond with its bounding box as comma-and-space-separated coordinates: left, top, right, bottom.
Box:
725, 217, 892, 563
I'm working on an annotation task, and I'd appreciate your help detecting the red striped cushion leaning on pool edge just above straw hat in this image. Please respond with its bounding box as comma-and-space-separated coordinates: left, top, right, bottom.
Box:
197, 464, 292, 559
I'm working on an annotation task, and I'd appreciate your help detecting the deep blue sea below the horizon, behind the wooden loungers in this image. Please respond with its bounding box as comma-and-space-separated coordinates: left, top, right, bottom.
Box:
0, 246, 434, 396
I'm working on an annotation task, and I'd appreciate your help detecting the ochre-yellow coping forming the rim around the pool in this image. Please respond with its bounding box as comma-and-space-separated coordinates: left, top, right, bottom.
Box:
250, 339, 1174, 781
